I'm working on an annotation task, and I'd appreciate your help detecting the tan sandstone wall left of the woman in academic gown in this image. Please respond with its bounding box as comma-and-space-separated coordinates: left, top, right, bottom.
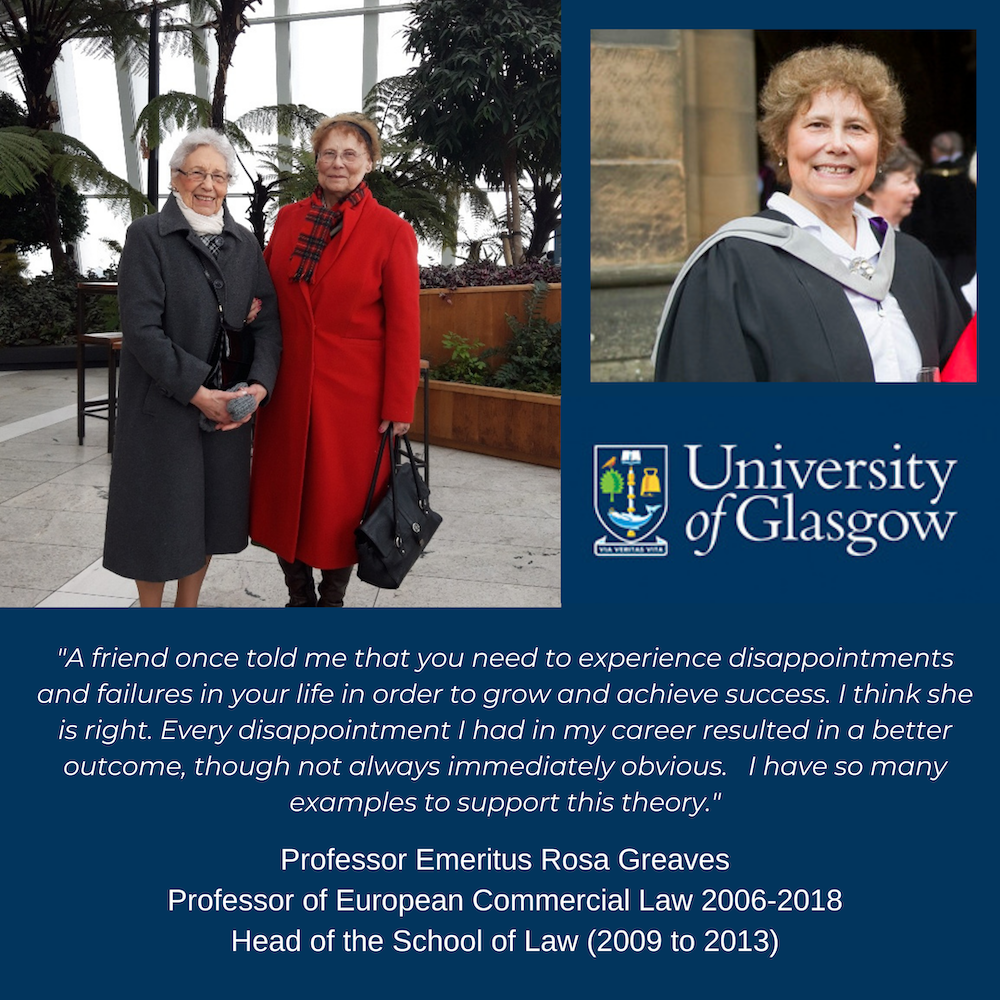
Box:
590, 28, 757, 382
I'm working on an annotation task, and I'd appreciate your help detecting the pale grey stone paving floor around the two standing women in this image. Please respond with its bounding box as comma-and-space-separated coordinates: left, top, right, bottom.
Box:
0, 369, 560, 608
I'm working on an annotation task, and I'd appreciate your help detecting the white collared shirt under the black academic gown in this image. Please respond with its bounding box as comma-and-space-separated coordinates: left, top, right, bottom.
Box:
767, 191, 922, 382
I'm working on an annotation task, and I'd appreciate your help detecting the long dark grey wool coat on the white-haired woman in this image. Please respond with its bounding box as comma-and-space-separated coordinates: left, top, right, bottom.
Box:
104, 197, 281, 582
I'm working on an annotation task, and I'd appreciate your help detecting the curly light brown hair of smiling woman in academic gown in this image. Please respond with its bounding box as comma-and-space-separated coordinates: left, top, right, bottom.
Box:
757, 45, 905, 183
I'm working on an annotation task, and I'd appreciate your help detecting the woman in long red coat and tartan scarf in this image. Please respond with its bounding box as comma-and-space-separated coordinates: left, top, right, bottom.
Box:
250, 114, 420, 608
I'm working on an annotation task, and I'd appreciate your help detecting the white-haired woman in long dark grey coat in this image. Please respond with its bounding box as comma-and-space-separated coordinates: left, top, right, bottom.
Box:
104, 129, 281, 607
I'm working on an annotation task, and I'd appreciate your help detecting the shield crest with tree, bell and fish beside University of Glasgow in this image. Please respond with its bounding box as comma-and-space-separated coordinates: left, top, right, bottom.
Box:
594, 444, 667, 556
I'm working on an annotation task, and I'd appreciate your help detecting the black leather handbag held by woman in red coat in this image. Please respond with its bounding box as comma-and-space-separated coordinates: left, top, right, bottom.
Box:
354, 424, 441, 590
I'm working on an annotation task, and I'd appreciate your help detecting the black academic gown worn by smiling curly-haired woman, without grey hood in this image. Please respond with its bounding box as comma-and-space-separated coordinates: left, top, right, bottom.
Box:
655, 210, 963, 382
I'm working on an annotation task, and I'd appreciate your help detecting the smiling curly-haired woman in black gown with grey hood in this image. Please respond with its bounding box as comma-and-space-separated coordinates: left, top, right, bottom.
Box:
653, 45, 963, 382
